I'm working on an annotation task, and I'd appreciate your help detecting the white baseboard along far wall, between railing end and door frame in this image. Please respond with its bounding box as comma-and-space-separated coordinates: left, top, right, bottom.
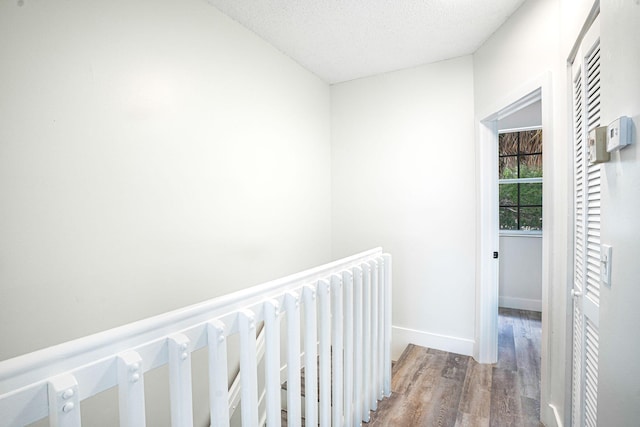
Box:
391, 326, 475, 360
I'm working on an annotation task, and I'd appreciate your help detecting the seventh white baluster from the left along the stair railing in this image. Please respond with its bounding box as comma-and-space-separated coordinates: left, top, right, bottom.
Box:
284, 292, 302, 425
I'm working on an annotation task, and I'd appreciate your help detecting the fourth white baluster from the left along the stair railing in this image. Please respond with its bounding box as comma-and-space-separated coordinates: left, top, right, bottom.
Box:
207, 320, 229, 427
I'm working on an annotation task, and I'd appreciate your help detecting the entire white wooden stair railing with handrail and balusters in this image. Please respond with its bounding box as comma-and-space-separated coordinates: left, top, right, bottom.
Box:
0, 248, 391, 427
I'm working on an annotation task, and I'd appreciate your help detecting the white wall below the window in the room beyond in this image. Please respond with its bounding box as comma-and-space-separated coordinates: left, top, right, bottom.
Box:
499, 235, 542, 311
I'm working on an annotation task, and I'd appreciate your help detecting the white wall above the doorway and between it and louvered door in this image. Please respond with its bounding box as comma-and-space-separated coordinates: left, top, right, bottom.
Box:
473, 0, 564, 425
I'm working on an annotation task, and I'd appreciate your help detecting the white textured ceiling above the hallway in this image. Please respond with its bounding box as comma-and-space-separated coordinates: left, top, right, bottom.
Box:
207, 0, 524, 83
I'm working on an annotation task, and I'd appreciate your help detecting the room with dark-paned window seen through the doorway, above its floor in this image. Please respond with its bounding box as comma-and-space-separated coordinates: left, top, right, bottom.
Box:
498, 101, 543, 312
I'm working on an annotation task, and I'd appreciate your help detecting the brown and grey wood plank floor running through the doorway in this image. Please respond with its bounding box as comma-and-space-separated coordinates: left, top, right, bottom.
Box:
369, 309, 542, 427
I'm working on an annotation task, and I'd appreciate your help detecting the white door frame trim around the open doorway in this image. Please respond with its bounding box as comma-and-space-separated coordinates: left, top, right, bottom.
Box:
475, 73, 553, 422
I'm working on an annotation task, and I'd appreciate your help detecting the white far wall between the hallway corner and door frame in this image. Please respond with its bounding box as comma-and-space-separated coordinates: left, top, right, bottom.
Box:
331, 56, 475, 357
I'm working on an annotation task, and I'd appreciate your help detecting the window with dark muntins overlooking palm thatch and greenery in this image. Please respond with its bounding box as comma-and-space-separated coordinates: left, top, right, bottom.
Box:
498, 129, 542, 233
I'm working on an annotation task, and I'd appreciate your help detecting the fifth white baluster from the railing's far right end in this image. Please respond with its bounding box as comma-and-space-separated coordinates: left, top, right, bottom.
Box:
351, 267, 364, 426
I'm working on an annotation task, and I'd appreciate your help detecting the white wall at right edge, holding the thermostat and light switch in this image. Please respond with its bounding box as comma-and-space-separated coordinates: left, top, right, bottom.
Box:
598, 0, 640, 427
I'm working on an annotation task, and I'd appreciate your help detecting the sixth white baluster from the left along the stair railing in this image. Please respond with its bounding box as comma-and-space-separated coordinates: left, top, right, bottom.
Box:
264, 300, 282, 427
